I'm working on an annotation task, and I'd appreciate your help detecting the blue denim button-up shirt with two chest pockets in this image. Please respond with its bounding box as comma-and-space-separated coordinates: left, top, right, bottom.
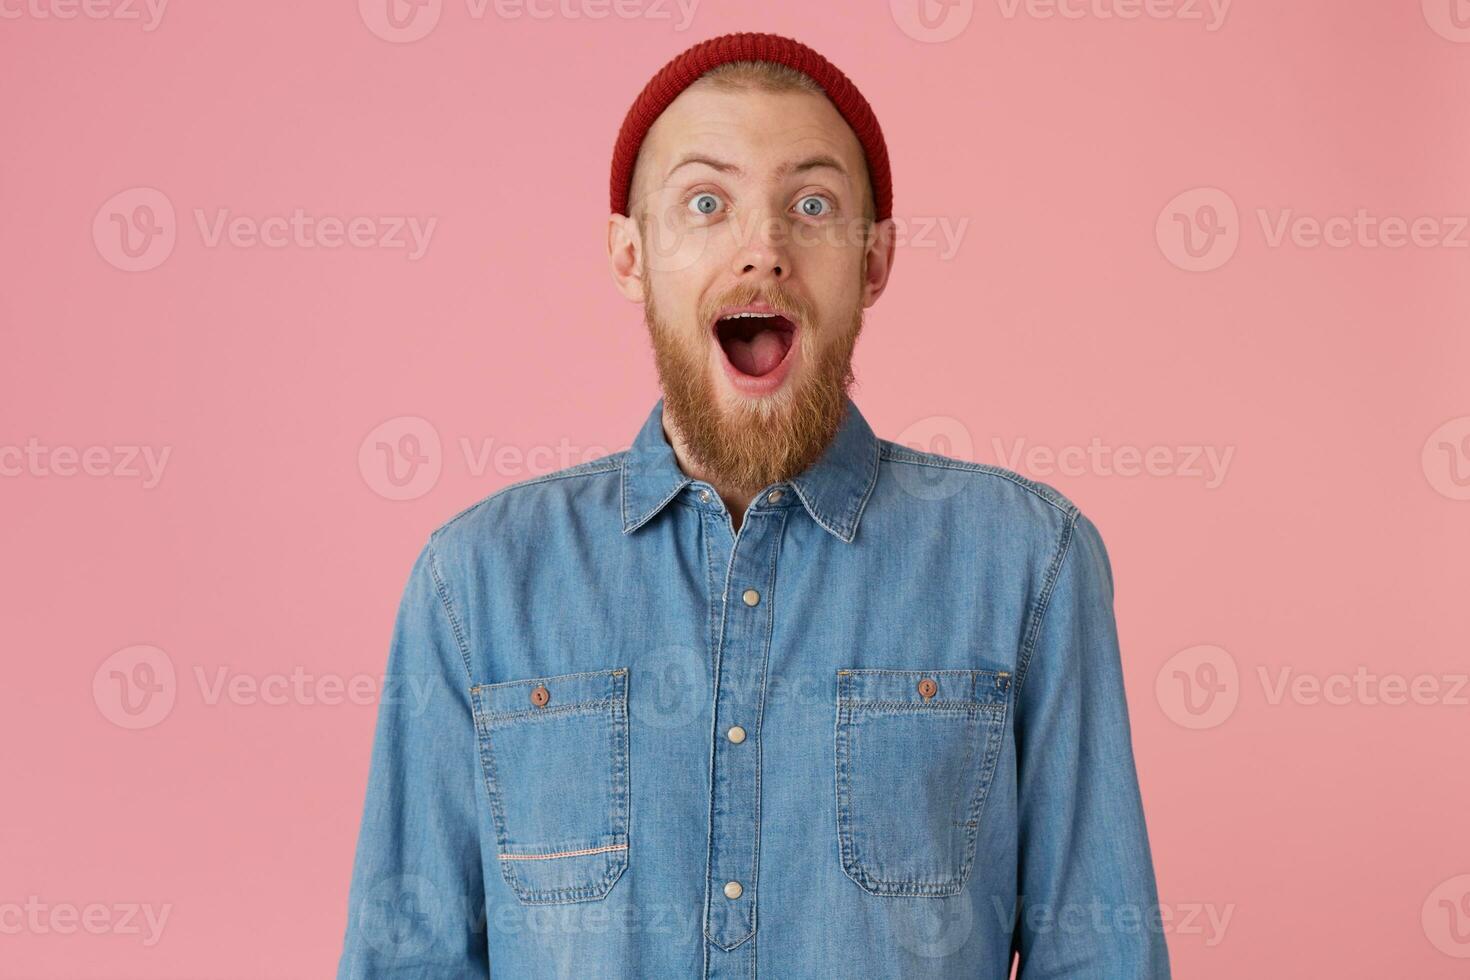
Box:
338, 400, 1169, 980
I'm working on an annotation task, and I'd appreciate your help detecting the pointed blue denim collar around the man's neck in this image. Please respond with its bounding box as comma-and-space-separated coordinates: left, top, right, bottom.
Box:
622, 398, 879, 542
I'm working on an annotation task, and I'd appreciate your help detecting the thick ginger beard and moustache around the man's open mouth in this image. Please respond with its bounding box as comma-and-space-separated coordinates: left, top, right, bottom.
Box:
644, 279, 863, 492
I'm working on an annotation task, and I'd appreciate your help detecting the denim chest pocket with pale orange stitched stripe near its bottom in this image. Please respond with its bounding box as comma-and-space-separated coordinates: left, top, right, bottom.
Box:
470, 667, 629, 905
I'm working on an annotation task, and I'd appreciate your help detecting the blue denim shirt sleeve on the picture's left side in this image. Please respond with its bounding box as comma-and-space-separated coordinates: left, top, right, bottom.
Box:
337, 539, 490, 980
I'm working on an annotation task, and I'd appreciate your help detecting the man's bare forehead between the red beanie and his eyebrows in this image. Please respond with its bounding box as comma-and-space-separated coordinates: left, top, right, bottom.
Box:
641, 84, 866, 184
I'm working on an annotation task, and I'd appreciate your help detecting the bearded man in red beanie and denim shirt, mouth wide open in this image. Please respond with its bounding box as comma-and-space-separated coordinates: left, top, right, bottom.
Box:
338, 34, 1169, 980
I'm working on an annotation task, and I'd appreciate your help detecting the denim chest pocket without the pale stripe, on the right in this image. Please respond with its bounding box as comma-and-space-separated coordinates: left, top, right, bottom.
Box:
835, 670, 1010, 896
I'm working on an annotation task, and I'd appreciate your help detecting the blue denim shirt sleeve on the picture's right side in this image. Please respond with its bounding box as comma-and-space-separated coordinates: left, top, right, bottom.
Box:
1013, 511, 1170, 980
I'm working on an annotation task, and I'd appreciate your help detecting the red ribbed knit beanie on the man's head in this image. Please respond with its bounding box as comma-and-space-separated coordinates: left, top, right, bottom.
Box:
612, 34, 894, 220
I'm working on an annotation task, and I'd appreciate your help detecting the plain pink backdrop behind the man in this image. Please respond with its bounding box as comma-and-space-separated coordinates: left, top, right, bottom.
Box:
0, 0, 1470, 979
